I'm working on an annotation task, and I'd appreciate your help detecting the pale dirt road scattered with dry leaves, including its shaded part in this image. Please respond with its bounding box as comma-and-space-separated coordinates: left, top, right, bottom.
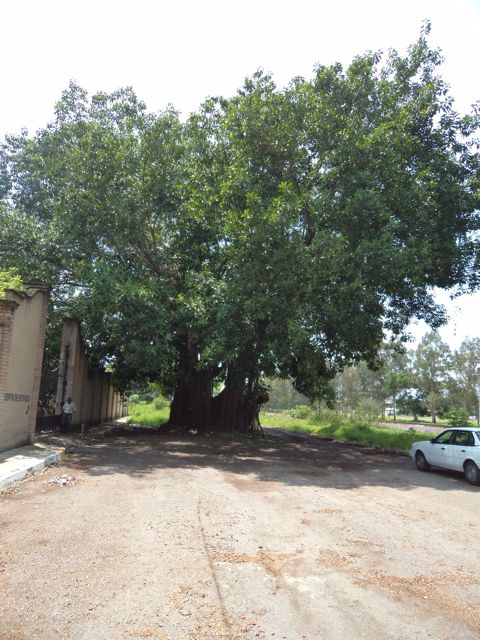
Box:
0, 430, 480, 640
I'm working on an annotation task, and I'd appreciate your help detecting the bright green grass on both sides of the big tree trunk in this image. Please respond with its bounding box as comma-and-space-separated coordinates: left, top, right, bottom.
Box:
124, 402, 435, 451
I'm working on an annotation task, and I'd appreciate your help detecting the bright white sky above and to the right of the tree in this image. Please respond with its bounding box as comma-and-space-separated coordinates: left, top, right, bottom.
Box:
0, 0, 480, 346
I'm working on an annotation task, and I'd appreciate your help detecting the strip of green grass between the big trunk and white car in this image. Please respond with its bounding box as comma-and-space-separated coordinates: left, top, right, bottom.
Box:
261, 413, 435, 451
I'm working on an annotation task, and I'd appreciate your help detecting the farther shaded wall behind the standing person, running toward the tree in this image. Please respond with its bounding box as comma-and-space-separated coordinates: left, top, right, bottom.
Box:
56, 318, 126, 425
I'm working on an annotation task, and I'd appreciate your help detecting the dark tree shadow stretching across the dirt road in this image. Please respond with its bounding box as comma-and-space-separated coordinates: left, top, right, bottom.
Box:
36, 428, 478, 491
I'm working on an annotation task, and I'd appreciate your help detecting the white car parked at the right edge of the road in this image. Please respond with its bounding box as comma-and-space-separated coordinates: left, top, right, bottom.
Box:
409, 427, 480, 485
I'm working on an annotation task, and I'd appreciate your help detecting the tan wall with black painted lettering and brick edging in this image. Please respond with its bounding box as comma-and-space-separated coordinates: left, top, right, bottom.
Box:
0, 284, 48, 451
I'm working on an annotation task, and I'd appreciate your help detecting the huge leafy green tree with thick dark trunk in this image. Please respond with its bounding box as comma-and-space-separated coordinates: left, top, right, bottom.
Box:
0, 28, 478, 430
